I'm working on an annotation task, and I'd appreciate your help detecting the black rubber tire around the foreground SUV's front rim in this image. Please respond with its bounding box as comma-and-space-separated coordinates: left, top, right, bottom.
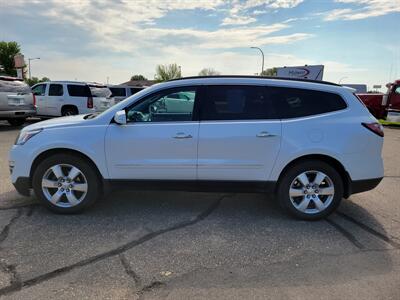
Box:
32, 154, 102, 214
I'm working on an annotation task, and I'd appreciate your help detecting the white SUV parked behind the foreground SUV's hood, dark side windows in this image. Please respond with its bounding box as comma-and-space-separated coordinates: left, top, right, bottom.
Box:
32, 81, 95, 117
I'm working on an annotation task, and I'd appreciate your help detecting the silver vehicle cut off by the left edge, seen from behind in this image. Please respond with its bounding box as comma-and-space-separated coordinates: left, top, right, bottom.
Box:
0, 76, 36, 126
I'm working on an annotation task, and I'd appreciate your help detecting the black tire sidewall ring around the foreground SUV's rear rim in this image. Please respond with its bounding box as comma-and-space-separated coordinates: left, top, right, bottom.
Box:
278, 160, 343, 220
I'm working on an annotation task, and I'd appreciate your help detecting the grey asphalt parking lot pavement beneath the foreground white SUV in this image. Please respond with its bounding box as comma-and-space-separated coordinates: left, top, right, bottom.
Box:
0, 123, 400, 299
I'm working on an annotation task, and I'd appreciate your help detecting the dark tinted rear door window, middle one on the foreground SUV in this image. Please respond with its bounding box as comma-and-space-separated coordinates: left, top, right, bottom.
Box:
200, 86, 275, 120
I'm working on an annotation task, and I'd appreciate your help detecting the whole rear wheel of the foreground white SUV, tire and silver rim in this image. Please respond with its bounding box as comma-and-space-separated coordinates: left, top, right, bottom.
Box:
278, 160, 343, 220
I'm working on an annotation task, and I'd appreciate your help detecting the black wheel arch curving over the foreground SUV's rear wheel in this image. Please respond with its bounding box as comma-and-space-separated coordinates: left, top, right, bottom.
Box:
278, 154, 351, 198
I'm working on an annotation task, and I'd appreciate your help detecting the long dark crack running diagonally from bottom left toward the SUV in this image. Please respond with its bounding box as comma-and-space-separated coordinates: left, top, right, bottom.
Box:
0, 195, 229, 296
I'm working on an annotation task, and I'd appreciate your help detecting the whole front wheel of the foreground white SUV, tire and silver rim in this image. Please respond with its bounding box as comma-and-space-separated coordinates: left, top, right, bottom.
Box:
32, 154, 101, 213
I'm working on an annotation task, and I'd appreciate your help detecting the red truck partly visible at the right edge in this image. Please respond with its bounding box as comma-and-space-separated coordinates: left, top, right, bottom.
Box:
357, 80, 400, 119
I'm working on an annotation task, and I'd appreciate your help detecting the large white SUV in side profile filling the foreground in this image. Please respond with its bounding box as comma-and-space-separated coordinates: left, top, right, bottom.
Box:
10, 76, 383, 219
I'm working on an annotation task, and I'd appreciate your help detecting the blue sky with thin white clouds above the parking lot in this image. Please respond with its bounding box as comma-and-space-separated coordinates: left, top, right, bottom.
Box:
0, 0, 400, 87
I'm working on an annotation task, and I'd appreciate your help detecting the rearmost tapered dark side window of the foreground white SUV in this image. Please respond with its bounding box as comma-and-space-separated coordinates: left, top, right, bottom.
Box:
267, 87, 347, 119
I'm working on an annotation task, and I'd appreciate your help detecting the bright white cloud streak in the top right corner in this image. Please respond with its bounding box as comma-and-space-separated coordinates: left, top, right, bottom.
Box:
324, 0, 400, 21
